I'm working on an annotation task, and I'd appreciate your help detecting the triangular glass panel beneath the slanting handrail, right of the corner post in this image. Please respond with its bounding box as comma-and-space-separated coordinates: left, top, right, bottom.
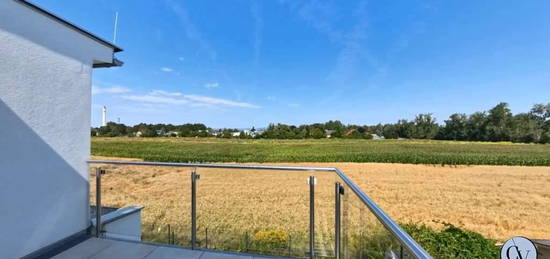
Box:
341, 181, 400, 259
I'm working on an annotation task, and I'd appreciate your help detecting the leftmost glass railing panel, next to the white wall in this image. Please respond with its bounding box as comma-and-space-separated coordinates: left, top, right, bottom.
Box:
90, 164, 191, 246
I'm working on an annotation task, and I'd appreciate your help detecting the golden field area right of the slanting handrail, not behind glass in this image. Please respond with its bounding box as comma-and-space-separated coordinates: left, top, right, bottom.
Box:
94, 157, 550, 243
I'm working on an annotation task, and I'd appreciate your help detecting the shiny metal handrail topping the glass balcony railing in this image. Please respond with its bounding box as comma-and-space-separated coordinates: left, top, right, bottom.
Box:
88, 160, 432, 259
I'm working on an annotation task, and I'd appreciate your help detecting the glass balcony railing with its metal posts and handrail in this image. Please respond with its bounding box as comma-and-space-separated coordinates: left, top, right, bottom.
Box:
89, 160, 431, 259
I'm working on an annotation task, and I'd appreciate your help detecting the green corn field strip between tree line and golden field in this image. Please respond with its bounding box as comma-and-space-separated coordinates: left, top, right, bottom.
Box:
92, 137, 550, 166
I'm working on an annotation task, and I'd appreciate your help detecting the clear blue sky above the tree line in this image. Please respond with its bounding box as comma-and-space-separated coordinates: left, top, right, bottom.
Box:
34, 0, 550, 128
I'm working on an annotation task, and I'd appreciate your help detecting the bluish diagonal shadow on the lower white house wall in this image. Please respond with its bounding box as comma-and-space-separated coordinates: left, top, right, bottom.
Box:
0, 99, 89, 258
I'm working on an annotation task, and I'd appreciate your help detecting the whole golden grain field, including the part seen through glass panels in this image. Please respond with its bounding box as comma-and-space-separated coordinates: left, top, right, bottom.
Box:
91, 158, 550, 248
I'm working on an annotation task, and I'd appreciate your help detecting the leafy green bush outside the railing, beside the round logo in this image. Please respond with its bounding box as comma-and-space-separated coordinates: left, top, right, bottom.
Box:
402, 223, 499, 259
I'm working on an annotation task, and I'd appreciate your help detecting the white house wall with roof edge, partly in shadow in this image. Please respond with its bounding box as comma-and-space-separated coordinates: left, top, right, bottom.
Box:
0, 0, 118, 258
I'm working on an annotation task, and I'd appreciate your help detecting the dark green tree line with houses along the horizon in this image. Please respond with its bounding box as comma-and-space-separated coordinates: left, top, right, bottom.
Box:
92, 103, 550, 143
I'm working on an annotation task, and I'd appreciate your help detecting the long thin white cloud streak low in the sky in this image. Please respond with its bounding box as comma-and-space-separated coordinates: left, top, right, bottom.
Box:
122, 90, 260, 108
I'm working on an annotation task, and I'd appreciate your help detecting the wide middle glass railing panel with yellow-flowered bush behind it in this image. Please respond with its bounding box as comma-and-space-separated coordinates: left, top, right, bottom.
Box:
197, 168, 324, 257
